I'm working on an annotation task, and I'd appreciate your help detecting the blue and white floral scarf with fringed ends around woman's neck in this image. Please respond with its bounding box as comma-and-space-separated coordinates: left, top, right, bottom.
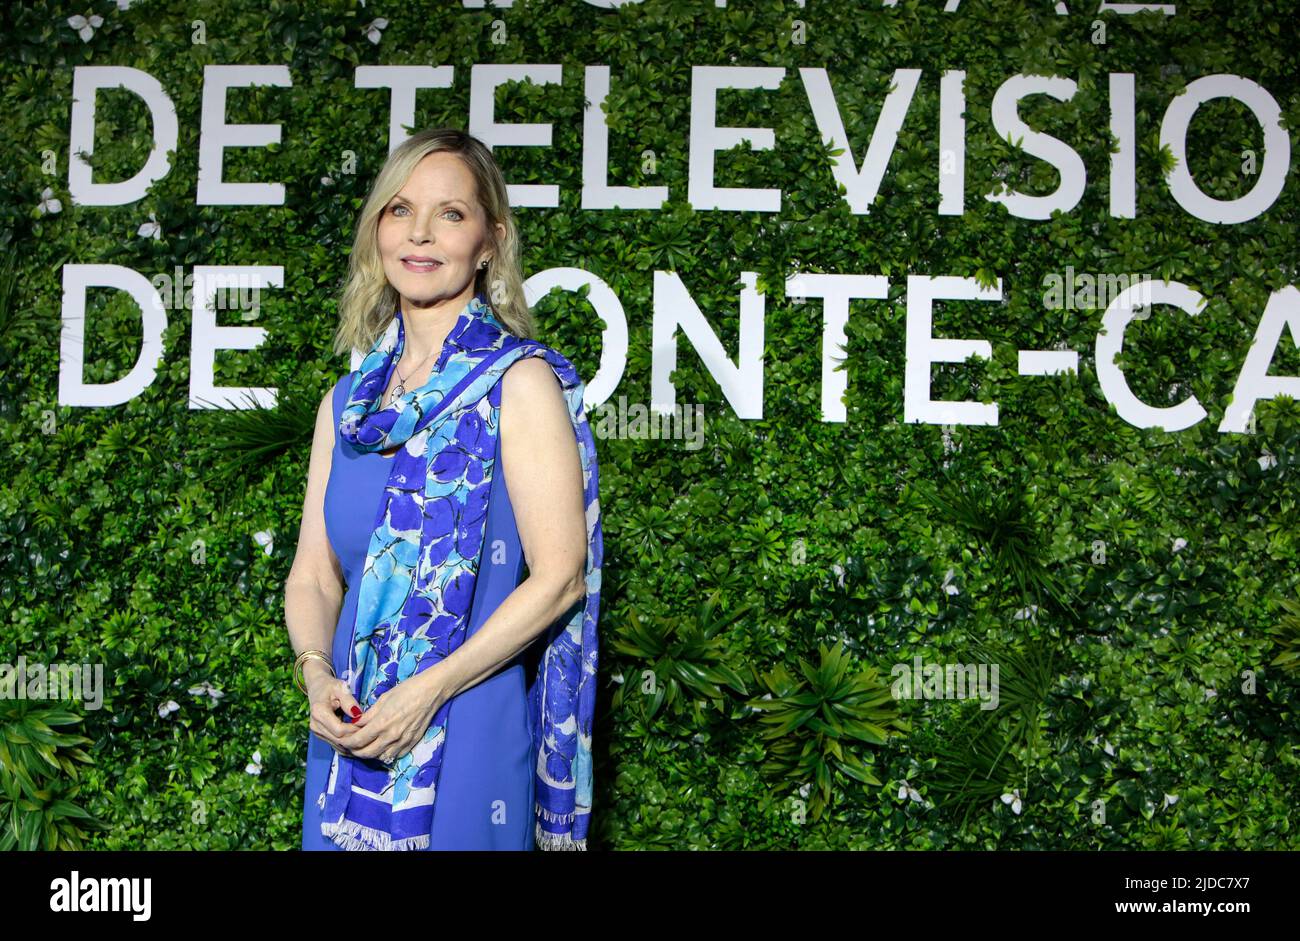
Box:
319, 294, 603, 850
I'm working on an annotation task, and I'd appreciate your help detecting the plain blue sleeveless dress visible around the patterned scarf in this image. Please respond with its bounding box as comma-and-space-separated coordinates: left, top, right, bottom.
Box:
303, 373, 537, 850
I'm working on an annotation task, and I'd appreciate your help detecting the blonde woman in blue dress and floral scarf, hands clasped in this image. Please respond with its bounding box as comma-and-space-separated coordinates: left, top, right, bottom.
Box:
285, 129, 603, 850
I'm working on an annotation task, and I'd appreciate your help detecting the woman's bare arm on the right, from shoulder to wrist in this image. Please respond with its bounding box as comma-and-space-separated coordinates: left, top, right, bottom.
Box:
425, 356, 586, 698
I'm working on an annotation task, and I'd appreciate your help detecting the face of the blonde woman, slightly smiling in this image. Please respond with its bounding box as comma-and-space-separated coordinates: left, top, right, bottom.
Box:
378, 152, 504, 312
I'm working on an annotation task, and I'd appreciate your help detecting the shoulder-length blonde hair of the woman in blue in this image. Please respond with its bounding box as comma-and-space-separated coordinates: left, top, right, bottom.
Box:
334, 127, 533, 354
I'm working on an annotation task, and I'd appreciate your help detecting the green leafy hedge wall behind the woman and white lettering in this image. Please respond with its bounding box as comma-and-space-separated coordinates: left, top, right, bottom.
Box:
0, 0, 1300, 849
